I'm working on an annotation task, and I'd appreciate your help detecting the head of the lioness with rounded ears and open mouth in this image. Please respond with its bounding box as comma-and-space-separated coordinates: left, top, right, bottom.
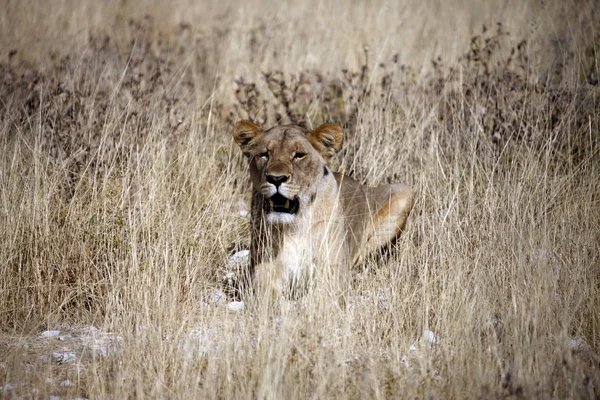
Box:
233, 121, 343, 224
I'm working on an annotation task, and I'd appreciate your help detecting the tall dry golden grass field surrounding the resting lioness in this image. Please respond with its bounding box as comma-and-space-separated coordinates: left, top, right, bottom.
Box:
0, 0, 600, 398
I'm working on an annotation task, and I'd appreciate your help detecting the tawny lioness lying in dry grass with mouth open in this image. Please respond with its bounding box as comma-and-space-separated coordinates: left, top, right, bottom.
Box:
233, 121, 413, 296
